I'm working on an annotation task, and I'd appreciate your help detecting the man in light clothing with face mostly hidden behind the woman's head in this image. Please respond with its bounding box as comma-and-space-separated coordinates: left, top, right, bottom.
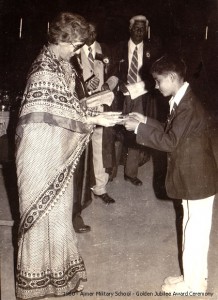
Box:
79, 23, 118, 204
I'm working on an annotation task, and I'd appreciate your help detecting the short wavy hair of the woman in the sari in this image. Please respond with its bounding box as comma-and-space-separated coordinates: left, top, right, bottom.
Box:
48, 12, 89, 44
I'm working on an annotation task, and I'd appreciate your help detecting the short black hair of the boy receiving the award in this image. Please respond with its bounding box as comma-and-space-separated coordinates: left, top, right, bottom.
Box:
151, 54, 187, 79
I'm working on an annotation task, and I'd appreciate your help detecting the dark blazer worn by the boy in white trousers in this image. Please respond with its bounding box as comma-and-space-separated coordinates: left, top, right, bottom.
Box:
136, 87, 217, 200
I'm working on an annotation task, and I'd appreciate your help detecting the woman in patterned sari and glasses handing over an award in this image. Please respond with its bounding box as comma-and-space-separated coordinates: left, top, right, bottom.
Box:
16, 13, 121, 299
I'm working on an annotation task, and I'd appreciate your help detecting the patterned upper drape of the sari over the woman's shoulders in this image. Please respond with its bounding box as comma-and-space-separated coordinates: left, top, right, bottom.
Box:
17, 47, 97, 142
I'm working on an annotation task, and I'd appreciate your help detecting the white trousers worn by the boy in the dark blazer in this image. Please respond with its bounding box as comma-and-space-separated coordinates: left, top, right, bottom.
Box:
182, 195, 215, 292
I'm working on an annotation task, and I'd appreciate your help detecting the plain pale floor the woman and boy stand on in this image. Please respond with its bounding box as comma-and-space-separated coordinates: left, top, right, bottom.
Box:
0, 126, 218, 300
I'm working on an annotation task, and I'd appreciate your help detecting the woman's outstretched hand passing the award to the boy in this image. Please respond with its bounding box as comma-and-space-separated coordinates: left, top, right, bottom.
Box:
87, 111, 123, 127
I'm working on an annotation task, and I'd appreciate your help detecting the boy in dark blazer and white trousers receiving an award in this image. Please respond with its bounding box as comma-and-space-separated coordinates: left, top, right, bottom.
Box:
124, 55, 217, 293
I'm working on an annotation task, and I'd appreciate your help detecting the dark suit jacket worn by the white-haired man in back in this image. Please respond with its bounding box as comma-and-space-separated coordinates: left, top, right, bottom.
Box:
114, 41, 164, 151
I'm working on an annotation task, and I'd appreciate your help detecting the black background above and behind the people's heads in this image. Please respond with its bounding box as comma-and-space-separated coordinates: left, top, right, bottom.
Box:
0, 0, 218, 113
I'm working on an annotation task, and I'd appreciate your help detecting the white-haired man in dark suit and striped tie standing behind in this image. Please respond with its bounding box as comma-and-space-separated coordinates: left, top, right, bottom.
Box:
114, 15, 161, 186
